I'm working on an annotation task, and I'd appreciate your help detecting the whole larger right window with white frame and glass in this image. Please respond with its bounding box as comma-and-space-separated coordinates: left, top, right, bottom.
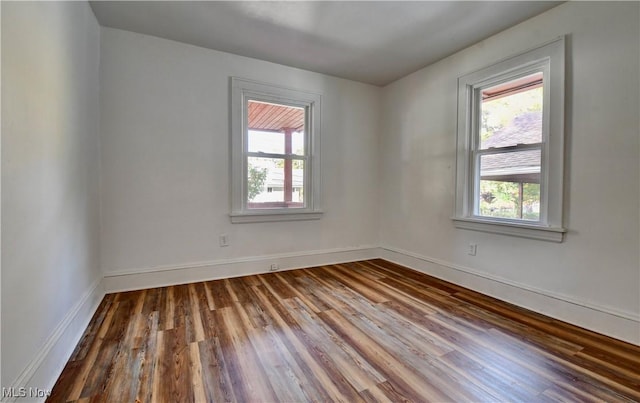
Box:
454, 38, 566, 242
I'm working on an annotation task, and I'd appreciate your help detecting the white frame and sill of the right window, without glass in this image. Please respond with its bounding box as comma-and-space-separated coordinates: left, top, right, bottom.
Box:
453, 37, 566, 242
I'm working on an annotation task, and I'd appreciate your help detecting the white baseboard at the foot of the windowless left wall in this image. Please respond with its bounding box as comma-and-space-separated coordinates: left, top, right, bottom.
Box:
2, 278, 105, 402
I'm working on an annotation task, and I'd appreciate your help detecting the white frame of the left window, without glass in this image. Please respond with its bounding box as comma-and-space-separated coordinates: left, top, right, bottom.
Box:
230, 77, 322, 223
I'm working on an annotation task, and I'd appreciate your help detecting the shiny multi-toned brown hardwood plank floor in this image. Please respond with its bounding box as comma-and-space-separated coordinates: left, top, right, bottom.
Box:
49, 260, 640, 402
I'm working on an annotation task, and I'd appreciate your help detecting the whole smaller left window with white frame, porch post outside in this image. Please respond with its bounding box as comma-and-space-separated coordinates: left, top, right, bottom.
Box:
231, 77, 322, 223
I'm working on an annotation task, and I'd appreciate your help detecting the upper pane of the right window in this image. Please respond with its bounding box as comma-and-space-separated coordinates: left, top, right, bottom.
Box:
480, 73, 543, 149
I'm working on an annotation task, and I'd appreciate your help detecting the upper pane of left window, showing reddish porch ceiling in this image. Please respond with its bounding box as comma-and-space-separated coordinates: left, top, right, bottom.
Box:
247, 101, 305, 155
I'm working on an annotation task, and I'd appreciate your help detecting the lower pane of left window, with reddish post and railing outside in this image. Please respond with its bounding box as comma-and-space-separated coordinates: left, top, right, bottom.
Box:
247, 157, 305, 209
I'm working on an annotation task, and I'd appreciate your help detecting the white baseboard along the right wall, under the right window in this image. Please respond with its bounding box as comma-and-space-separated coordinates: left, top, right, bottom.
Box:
379, 247, 640, 345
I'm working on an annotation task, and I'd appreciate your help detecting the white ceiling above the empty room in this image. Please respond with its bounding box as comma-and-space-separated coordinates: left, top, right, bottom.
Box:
91, 1, 561, 85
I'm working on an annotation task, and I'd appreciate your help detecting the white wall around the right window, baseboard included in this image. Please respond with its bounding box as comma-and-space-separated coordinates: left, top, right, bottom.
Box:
379, 2, 640, 343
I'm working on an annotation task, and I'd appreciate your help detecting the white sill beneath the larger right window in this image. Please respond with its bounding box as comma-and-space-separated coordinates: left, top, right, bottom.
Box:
453, 217, 567, 242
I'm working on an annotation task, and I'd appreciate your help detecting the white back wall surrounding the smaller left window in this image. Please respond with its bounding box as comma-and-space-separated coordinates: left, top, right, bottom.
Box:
100, 28, 380, 278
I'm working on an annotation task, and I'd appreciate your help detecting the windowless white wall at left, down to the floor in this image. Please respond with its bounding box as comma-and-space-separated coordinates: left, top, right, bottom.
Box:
1, 2, 102, 388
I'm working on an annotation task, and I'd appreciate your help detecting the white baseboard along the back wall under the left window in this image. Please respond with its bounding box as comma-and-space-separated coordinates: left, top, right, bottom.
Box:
104, 246, 380, 293
